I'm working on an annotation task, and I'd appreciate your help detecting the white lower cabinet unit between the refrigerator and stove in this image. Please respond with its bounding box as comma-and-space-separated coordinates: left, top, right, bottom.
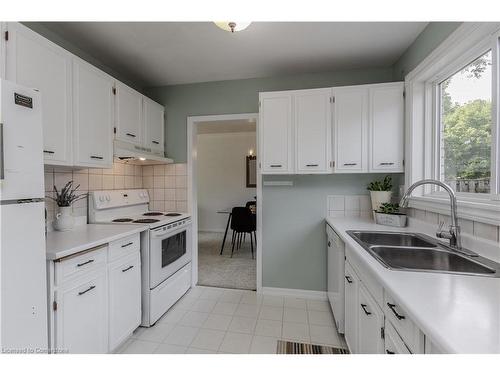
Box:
48, 234, 142, 354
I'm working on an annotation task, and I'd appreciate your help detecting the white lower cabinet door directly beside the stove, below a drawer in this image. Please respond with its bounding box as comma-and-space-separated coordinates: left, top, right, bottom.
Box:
108, 251, 141, 351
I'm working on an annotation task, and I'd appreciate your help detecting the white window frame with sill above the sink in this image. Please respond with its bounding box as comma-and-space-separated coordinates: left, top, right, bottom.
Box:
405, 22, 500, 225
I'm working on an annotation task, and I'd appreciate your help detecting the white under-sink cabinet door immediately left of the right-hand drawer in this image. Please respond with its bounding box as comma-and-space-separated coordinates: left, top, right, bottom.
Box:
357, 283, 385, 354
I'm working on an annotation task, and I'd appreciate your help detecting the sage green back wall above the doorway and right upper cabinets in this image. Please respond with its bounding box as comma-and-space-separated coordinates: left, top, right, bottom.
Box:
146, 68, 392, 163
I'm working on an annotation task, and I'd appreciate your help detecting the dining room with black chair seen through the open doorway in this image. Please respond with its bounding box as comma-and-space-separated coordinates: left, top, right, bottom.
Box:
195, 119, 257, 290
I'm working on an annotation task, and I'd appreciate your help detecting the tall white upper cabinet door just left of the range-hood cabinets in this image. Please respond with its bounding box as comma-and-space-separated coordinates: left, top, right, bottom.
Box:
73, 58, 113, 168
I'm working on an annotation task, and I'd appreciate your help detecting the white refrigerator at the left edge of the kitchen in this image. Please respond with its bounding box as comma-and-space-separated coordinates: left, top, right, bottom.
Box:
0, 80, 48, 353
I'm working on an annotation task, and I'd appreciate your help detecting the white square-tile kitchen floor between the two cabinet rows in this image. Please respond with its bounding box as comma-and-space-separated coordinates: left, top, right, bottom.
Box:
118, 286, 345, 354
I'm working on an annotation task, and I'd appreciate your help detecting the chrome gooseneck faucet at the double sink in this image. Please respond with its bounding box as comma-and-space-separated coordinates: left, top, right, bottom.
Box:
399, 179, 462, 250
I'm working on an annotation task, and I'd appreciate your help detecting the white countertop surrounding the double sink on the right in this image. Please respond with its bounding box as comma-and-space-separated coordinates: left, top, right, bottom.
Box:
326, 218, 500, 353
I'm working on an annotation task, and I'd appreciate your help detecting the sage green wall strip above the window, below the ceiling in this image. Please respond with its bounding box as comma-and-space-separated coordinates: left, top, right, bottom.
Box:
393, 22, 462, 81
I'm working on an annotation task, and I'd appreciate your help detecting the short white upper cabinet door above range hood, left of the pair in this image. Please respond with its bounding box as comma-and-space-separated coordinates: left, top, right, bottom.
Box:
115, 81, 143, 146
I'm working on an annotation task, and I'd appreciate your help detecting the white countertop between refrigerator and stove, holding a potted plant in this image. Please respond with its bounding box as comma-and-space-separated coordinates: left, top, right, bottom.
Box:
45, 224, 148, 260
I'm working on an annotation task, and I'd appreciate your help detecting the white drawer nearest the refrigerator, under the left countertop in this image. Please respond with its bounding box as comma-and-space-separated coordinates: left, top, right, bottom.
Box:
55, 245, 108, 284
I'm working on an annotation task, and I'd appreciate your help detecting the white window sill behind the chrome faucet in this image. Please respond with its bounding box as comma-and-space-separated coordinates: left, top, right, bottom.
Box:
408, 196, 500, 226
